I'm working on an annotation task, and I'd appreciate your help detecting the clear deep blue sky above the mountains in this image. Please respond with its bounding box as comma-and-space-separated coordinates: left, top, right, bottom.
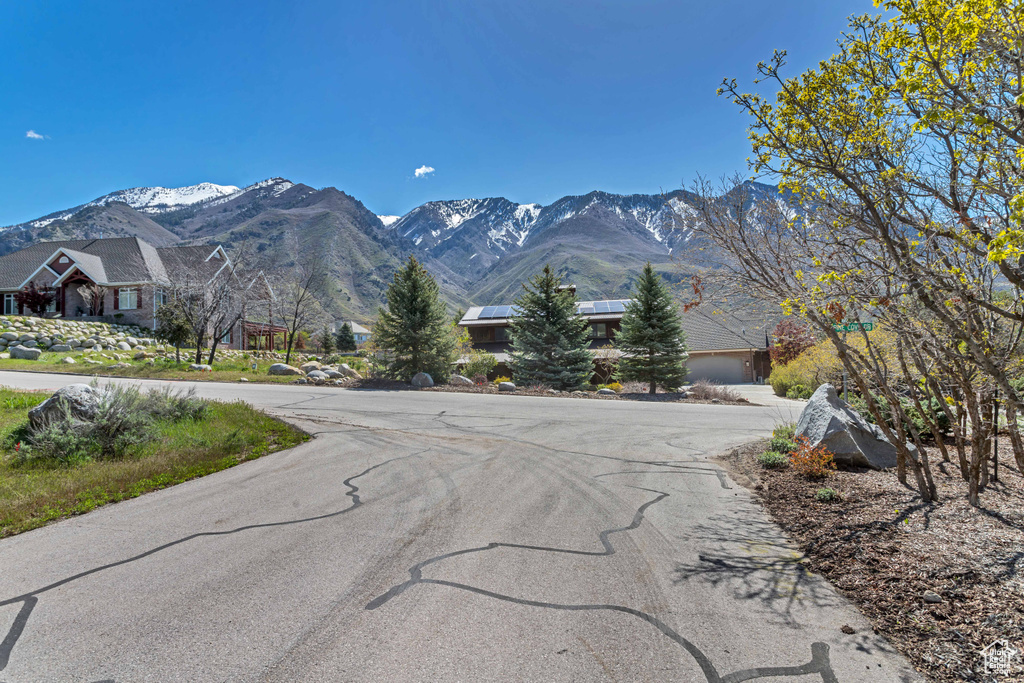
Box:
0, 0, 873, 225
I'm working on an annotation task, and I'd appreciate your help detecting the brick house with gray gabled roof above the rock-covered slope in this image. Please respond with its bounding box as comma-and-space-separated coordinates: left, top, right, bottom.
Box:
0, 238, 280, 348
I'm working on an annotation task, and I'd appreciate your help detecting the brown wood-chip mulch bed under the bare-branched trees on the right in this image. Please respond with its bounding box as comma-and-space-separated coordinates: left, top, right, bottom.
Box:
721, 442, 1024, 683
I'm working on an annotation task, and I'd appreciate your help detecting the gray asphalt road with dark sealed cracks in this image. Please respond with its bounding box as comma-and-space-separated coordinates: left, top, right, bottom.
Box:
0, 373, 918, 683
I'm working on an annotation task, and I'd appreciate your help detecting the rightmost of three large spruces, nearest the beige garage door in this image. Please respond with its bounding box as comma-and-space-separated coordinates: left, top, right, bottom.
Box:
614, 262, 687, 393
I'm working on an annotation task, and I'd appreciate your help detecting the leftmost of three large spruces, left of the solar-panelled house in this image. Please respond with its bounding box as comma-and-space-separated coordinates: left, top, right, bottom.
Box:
374, 256, 457, 382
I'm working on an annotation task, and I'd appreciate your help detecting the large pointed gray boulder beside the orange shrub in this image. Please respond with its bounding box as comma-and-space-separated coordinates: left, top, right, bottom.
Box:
796, 384, 896, 470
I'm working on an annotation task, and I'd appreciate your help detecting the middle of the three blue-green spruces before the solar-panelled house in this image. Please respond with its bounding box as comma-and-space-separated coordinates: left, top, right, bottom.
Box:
509, 265, 594, 390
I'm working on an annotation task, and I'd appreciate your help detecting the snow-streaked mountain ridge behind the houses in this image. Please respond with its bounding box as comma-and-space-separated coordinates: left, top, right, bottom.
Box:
0, 176, 778, 321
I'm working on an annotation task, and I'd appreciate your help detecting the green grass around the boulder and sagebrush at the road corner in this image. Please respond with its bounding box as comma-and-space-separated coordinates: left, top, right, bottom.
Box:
0, 388, 309, 538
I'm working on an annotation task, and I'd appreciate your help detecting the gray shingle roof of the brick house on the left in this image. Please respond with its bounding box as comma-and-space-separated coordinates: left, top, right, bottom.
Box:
0, 238, 224, 290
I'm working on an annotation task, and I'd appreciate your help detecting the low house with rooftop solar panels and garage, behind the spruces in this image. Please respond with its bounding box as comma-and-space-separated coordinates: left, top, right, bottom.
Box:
459, 299, 771, 384
